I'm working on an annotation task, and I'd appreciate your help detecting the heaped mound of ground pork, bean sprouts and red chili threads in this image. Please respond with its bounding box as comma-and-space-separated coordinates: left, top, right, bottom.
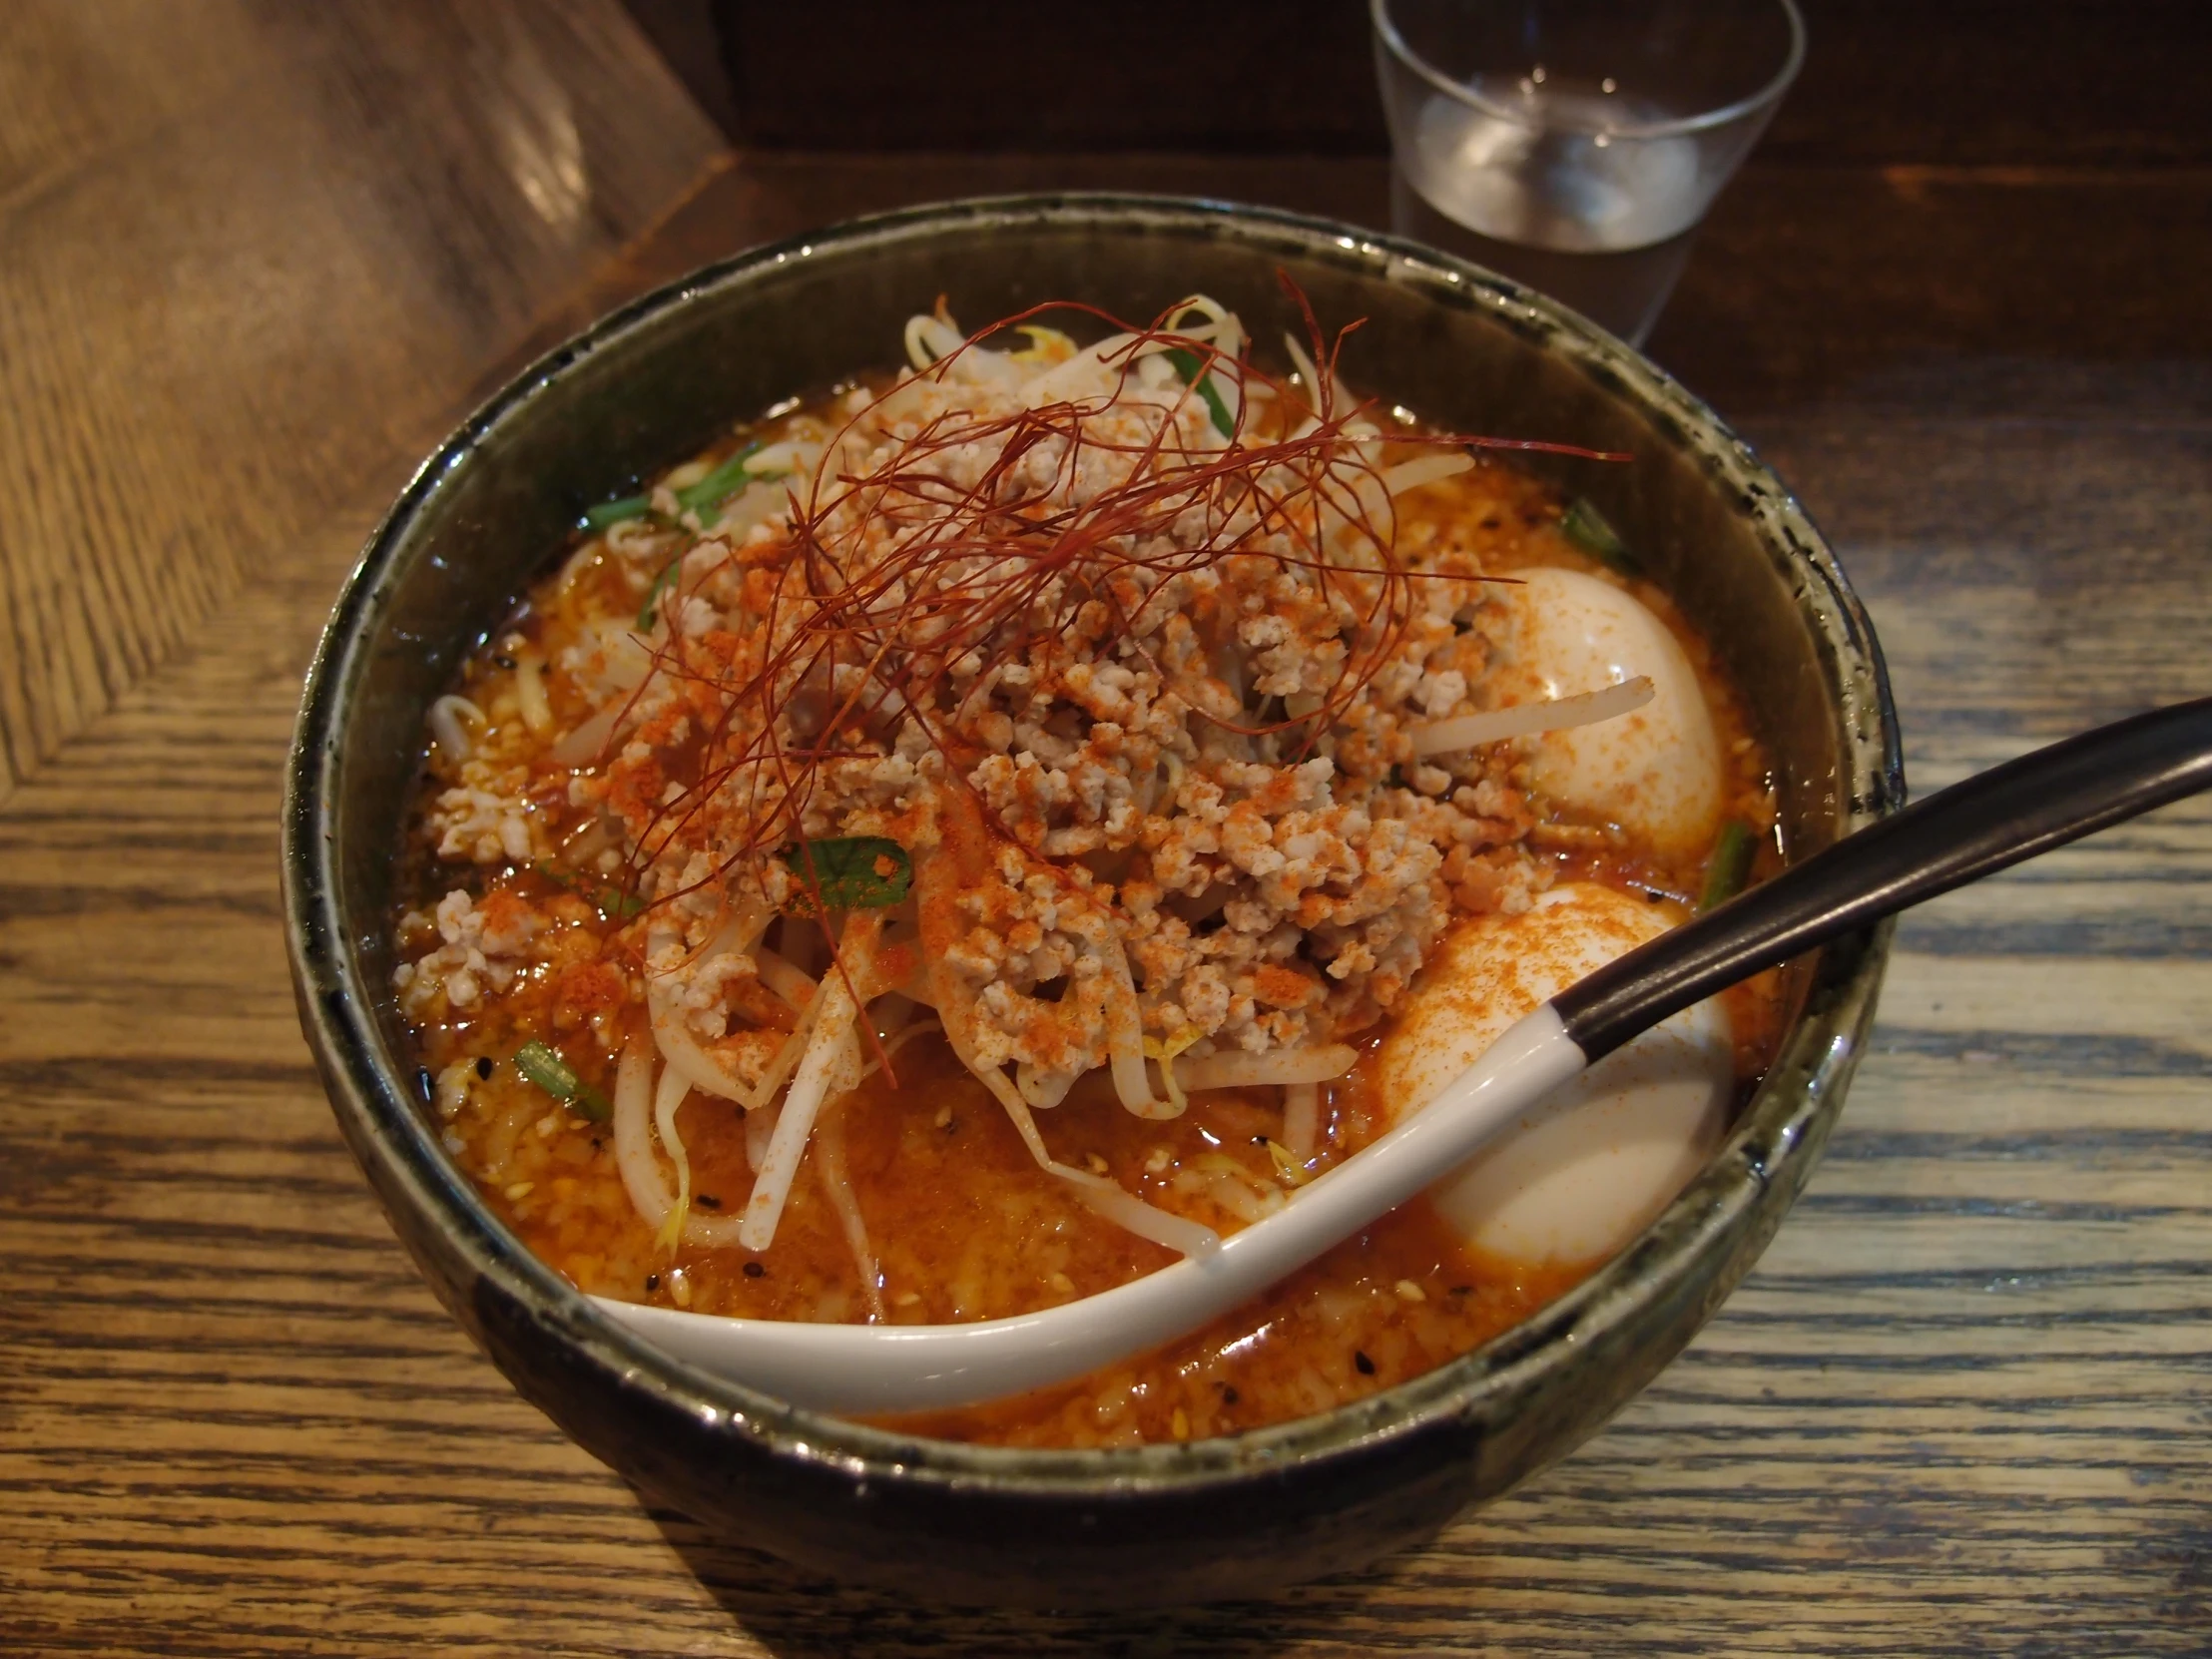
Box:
396, 298, 1645, 1248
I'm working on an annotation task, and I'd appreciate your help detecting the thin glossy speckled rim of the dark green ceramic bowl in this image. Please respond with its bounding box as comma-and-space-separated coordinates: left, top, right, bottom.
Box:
280, 193, 1903, 1497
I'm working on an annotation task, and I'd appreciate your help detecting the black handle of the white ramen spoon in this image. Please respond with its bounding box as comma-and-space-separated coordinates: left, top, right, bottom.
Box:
1553, 697, 2212, 1059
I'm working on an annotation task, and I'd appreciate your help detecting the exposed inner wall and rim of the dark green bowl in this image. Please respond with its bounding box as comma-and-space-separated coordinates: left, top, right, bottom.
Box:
287, 197, 1901, 1530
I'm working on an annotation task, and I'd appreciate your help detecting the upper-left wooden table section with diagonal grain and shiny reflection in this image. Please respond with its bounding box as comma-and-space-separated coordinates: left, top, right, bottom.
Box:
0, 0, 719, 799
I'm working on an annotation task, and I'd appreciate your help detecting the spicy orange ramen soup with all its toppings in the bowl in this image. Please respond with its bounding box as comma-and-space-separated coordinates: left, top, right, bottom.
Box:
393, 296, 1776, 1444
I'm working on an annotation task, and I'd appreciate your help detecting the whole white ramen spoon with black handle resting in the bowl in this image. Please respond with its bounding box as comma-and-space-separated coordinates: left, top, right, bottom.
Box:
593, 697, 2212, 1411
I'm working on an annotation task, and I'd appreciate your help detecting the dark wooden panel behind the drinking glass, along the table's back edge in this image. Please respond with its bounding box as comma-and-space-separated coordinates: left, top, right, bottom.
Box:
626, 0, 2212, 166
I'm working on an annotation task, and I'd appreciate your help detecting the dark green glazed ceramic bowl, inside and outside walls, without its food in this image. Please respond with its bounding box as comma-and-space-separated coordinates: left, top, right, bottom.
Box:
283, 197, 1903, 1606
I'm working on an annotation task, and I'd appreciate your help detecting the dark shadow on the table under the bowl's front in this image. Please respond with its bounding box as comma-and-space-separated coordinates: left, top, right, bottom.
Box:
633, 1488, 1393, 1659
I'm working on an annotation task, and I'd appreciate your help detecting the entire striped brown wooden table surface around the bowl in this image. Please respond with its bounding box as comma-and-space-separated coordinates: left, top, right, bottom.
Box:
0, 0, 2212, 1659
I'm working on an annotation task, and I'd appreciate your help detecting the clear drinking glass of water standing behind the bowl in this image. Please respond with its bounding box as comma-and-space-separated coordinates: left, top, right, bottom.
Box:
1370, 0, 1805, 342
